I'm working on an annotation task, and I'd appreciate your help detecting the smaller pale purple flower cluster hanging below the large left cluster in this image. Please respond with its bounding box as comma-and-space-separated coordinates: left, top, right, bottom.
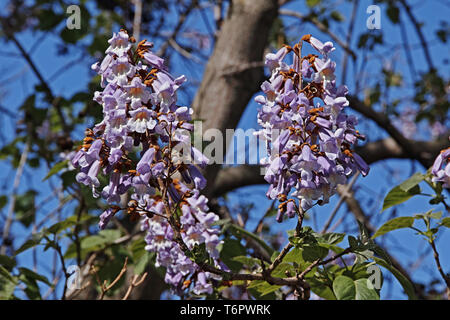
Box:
142, 188, 226, 294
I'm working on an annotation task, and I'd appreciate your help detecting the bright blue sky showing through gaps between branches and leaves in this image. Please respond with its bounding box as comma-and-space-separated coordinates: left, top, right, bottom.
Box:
0, 0, 450, 298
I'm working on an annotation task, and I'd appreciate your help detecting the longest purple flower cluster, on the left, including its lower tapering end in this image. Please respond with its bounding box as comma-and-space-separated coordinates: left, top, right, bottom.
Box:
72, 30, 221, 294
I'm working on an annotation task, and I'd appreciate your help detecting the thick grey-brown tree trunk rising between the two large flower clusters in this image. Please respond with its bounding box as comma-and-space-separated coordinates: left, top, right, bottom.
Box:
193, 0, 278, 194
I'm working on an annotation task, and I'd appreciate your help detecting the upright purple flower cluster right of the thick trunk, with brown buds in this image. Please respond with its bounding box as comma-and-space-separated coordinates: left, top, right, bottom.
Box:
255, 35, 369, 221
